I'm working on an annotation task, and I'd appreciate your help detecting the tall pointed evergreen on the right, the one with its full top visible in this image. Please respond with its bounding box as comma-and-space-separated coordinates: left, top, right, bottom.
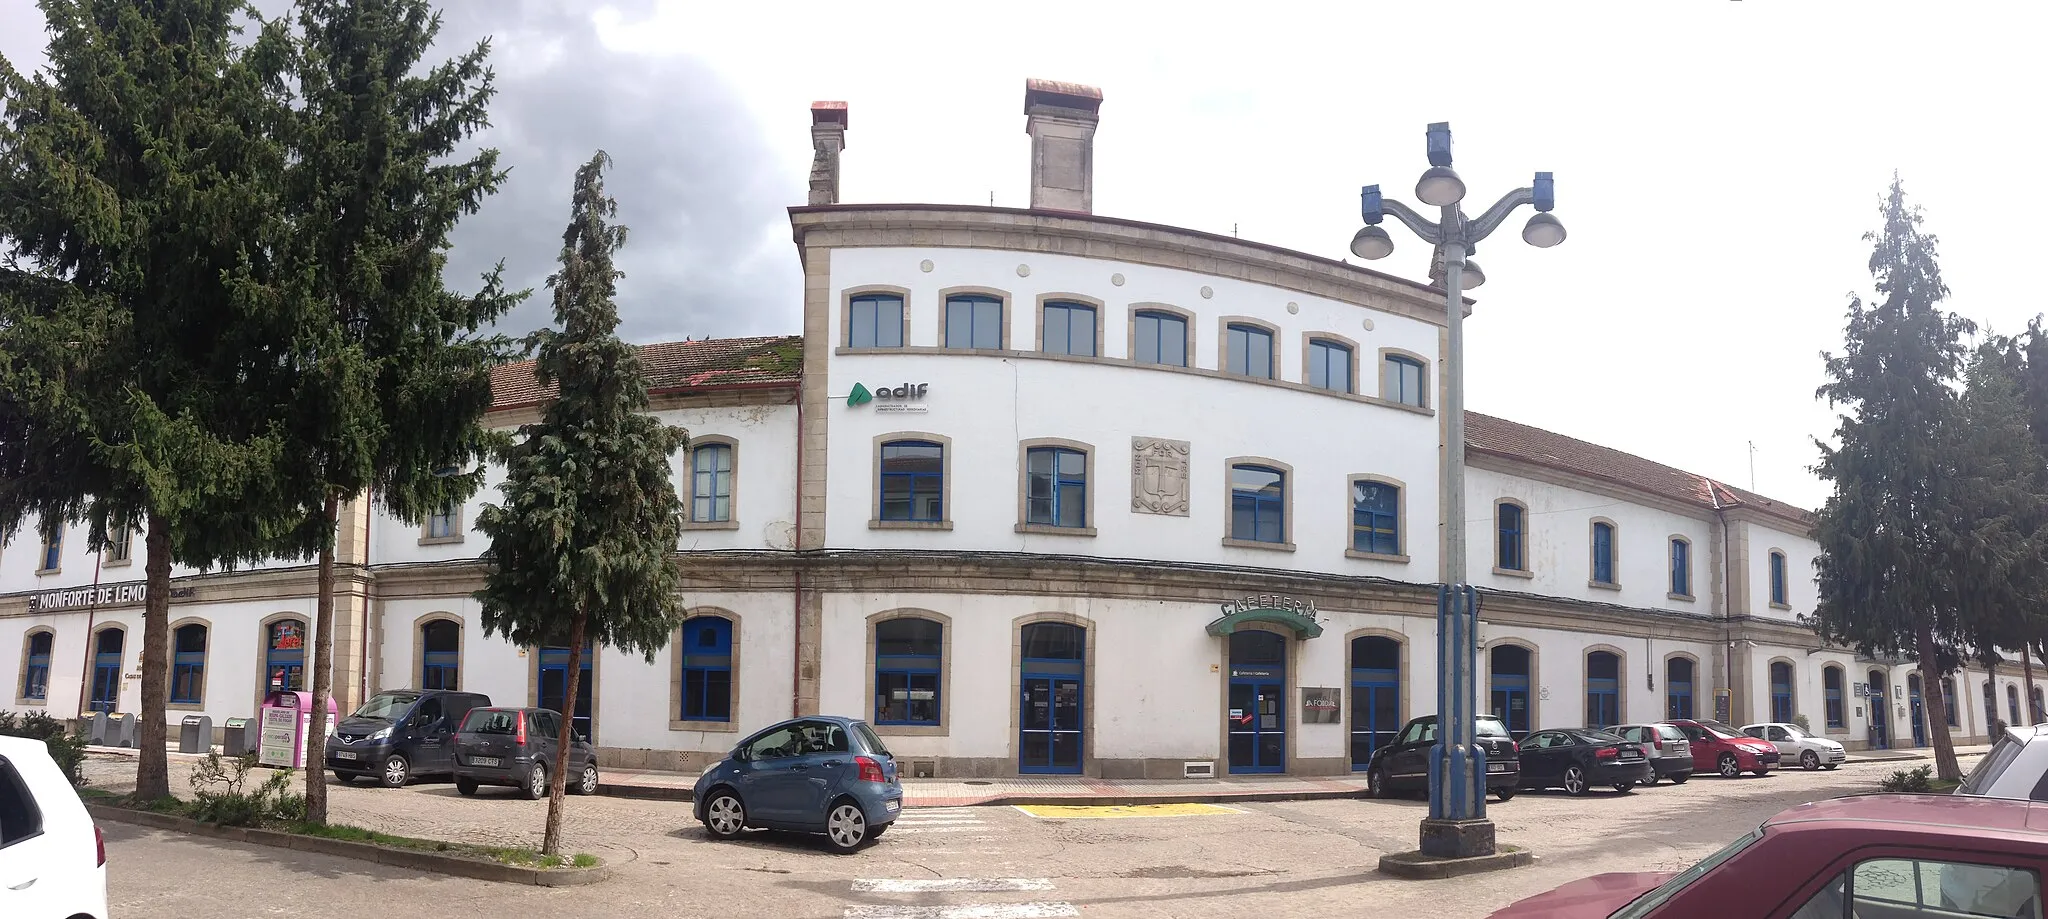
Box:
1812, 176, 1976, 778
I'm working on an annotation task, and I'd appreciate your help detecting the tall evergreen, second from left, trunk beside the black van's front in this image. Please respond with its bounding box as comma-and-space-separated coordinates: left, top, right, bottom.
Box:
279, 0, 524, 823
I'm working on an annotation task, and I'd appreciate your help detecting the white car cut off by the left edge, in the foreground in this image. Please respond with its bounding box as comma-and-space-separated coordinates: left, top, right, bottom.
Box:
0, 737, 106, 919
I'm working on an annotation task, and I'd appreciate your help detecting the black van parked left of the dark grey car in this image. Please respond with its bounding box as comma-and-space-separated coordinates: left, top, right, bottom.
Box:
328, 690, 492, 788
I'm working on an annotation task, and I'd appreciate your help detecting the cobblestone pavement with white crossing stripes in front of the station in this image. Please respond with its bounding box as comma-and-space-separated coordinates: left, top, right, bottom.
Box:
88, 757, 1968, 919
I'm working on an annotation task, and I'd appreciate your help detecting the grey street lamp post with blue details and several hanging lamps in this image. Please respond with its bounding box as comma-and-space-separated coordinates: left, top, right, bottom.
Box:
1352, 123, 1565, 858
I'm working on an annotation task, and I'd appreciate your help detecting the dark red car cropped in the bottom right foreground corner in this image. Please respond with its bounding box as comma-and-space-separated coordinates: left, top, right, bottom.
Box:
1493, 794, 2048, 919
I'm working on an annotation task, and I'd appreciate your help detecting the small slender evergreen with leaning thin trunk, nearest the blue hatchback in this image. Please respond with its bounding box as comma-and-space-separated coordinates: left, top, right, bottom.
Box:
477, 151, 688, 856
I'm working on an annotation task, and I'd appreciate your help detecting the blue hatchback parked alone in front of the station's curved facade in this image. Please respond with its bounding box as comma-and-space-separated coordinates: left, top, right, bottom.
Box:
696, 714, 903, 851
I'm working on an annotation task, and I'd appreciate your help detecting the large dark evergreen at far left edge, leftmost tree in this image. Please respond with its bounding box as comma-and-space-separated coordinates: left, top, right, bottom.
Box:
0, 0, 311, 798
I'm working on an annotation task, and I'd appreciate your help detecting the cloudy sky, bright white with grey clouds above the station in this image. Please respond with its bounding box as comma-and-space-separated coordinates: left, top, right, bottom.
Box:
0, 0, 2048, 506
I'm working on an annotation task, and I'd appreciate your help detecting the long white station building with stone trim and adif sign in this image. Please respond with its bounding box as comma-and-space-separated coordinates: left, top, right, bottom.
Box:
0, 80, 2048, 778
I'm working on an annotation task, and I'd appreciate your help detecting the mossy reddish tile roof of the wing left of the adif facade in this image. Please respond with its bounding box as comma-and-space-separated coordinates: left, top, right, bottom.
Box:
492, 336, 803, 409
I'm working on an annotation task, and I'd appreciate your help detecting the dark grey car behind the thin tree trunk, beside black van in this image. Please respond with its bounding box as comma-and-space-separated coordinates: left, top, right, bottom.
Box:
455, 708, 598, 800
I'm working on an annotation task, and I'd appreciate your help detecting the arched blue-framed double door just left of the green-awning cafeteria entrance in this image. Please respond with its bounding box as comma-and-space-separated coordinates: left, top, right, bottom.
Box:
1018, 622, 1087, 776
